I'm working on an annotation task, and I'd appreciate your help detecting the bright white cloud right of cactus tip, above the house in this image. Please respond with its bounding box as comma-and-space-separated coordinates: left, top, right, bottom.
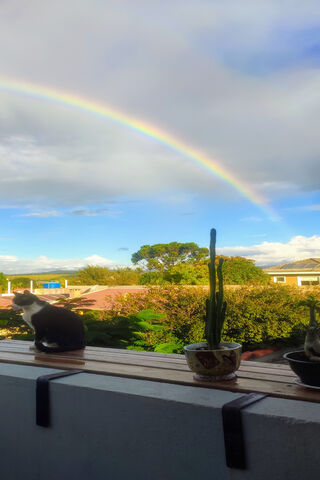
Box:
217, 235, 320, 266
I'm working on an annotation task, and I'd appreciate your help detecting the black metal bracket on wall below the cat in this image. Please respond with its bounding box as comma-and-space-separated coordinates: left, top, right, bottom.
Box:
36, 370, 83, 427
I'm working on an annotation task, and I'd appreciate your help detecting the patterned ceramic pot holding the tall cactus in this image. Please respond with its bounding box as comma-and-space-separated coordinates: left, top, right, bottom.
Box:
184, 342, 242, 382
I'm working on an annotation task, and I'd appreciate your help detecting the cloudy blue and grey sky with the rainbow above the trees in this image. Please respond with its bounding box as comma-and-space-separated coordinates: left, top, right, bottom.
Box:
0, 0, 320, 274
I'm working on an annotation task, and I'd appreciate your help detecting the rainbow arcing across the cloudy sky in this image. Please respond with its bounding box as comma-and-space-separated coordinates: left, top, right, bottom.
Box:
0, 76, 277, 219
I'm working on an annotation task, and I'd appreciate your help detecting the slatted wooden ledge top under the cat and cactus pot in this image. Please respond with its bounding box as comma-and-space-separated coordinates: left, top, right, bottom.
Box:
0, 340, 320, 402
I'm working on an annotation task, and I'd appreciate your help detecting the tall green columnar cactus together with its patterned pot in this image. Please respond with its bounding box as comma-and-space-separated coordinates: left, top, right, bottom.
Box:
184, 228, 241, 381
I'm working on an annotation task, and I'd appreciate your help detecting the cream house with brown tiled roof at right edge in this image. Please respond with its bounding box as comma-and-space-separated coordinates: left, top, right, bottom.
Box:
264, 258, 320, 286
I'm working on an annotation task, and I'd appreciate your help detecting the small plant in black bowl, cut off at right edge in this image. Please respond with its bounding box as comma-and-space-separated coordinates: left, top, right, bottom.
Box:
284, 295, 320, 388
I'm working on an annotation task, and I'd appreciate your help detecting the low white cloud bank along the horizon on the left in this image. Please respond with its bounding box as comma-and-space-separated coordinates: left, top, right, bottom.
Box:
0, 254, 116, 275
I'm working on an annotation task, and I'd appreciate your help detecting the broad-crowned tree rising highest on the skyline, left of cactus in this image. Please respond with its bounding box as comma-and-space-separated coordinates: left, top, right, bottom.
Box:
131, 242, 209, 272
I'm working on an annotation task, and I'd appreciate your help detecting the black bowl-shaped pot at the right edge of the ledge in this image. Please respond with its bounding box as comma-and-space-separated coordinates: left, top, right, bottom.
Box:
283, 350, 320, 387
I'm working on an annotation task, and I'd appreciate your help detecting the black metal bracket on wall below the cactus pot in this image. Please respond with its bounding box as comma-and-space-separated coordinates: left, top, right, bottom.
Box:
222, 393, 268, 470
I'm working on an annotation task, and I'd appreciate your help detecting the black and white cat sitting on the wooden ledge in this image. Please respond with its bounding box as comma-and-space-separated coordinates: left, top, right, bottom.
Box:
12, 290, 85, 353
